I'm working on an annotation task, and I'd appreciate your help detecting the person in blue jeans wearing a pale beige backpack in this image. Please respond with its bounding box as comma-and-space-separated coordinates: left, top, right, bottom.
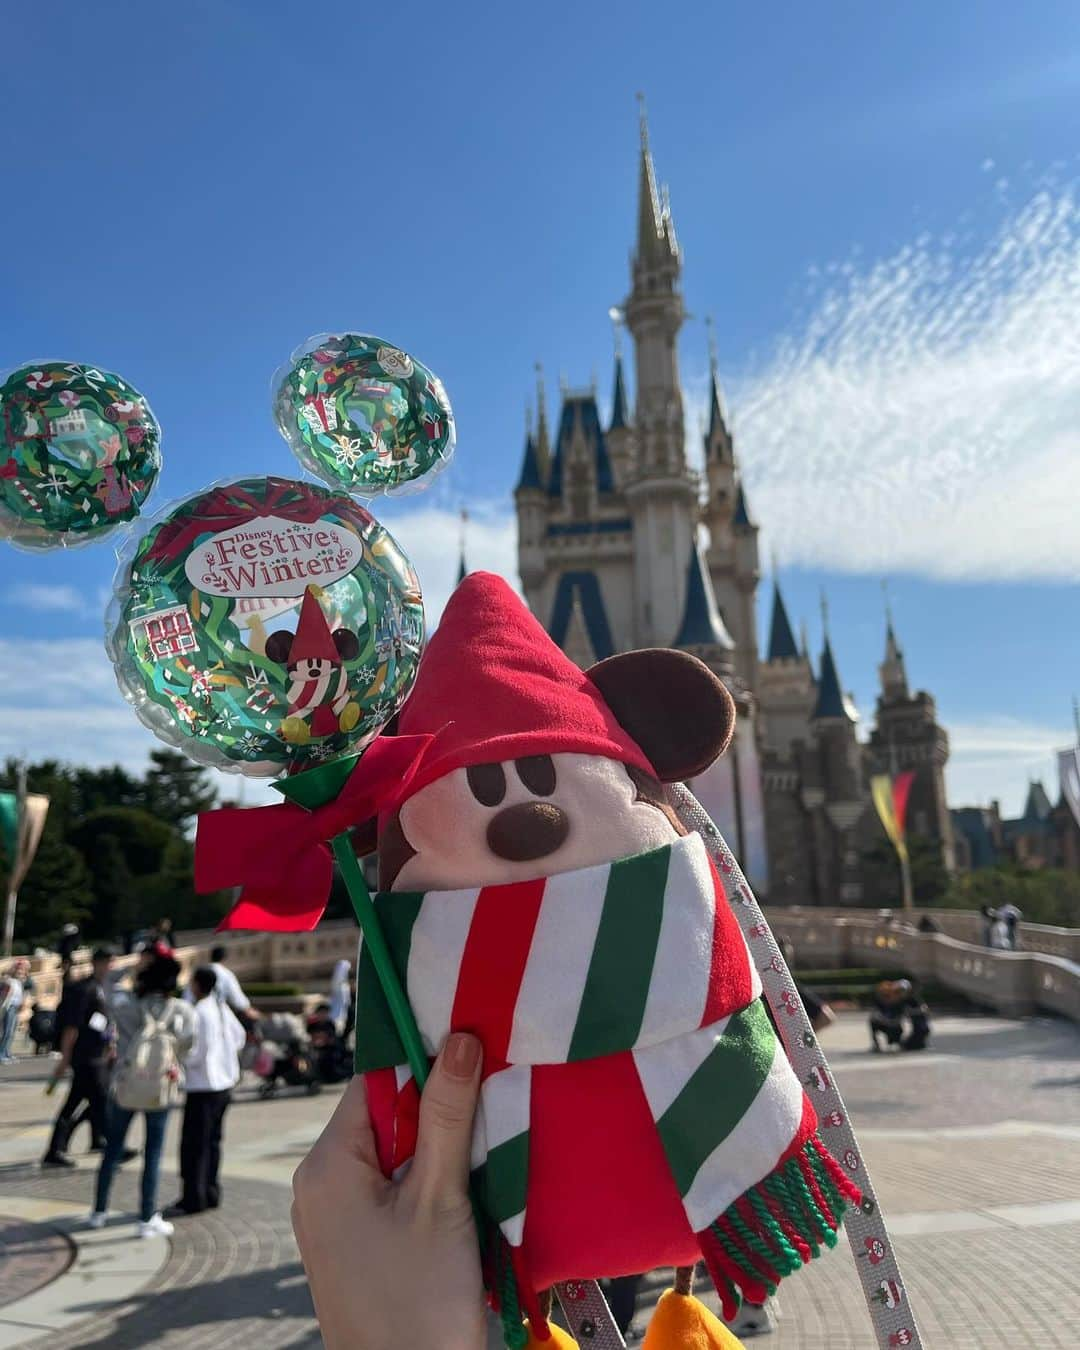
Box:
89, 945, 196, 1238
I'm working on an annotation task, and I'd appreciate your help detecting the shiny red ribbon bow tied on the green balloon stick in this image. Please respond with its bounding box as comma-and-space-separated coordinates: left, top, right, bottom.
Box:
194, 736, 435, 933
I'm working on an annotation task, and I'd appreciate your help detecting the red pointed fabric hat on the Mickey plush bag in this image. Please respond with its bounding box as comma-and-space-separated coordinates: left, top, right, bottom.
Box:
391, 572, 653, 805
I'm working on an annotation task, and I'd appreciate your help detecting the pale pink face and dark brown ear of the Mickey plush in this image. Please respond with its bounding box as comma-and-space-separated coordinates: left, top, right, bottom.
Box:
369, 651, 734, 891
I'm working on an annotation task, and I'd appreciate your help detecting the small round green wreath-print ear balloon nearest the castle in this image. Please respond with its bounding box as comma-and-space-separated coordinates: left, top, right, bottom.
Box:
274, 333, 455, 497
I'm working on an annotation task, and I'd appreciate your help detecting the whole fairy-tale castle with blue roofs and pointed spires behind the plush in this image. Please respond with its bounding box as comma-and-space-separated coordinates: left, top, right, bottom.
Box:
514, 113, 953, 905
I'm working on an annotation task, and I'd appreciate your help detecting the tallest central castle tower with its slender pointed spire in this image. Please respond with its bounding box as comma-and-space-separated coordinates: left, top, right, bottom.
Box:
624, 108, 698, 647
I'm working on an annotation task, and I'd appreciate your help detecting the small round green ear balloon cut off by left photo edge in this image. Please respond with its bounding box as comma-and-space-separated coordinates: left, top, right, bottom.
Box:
0, 362, 161, 549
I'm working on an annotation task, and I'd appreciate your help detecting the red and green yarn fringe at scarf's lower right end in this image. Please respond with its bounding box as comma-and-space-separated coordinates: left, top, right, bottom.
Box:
697, 1135, 863, 1320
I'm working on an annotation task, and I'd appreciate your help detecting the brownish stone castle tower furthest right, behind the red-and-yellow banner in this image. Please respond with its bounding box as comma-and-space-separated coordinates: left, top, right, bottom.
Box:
867, 609, 956, 872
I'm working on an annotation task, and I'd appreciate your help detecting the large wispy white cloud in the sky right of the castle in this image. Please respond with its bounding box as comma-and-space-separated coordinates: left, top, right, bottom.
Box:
723, 186, 1080, 579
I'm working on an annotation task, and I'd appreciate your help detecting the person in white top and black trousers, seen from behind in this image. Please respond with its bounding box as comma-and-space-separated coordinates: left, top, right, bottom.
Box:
169, 965, 246, 1215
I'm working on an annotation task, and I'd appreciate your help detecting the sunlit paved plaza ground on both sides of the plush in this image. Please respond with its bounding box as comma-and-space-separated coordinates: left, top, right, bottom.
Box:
0, 1015, 1080, 1350
